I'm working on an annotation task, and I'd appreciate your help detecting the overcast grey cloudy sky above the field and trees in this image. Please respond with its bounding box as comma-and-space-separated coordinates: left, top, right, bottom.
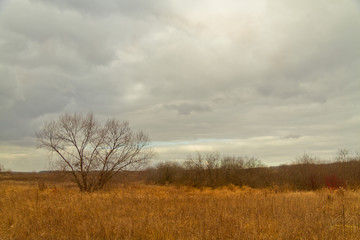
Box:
0, 0, 360, 171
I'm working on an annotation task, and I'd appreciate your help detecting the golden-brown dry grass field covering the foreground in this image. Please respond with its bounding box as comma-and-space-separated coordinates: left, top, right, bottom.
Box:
0, 181, 360, 240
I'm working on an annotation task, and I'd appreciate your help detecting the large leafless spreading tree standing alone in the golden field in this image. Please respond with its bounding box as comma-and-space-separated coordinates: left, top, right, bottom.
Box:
36, 113, 154, 192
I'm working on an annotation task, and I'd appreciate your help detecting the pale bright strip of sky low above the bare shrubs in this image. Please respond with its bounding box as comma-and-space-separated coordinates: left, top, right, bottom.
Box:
153, 135, 348, 165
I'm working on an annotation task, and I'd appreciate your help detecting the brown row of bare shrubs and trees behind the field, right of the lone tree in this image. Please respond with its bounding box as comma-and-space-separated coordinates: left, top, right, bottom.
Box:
143, 150, 360, 190
